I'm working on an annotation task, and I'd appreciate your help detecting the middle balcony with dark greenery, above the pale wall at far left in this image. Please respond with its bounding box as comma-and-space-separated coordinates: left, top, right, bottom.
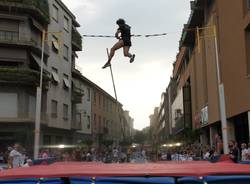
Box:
0, 67, 50, 87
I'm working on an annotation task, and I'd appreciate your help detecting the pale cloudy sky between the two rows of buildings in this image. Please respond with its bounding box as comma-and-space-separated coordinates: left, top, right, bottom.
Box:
62, 0, 190, 130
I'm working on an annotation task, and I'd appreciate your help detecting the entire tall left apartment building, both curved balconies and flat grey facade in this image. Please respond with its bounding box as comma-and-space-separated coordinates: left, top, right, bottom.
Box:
0, 0, 82, 151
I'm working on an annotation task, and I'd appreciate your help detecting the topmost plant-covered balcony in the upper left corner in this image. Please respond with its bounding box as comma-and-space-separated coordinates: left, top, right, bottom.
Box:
0, 0, 50, 24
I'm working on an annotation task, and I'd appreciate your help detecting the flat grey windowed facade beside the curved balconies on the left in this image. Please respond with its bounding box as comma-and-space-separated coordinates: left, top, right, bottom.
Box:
42, 0, 82, 145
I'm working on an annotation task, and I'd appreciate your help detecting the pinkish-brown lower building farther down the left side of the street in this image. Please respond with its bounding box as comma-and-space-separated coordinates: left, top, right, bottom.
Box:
92, 84, 124, 147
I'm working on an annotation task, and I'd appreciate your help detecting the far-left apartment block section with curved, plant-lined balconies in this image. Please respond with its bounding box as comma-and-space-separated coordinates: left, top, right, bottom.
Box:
0, 0, 49, 148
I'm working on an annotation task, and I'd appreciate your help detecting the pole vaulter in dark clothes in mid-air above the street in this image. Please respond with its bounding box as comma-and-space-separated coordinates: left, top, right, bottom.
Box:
102, 19, 135, 69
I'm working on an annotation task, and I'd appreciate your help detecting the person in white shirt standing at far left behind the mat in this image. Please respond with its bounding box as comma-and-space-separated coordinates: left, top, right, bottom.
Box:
9, 143, 22, 168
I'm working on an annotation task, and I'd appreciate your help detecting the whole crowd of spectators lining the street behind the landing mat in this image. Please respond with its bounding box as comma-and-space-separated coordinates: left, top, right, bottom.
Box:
0, 139, 250, 168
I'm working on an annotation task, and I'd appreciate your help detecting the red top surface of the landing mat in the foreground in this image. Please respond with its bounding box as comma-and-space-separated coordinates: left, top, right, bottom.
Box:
0, 161, 250, 179
